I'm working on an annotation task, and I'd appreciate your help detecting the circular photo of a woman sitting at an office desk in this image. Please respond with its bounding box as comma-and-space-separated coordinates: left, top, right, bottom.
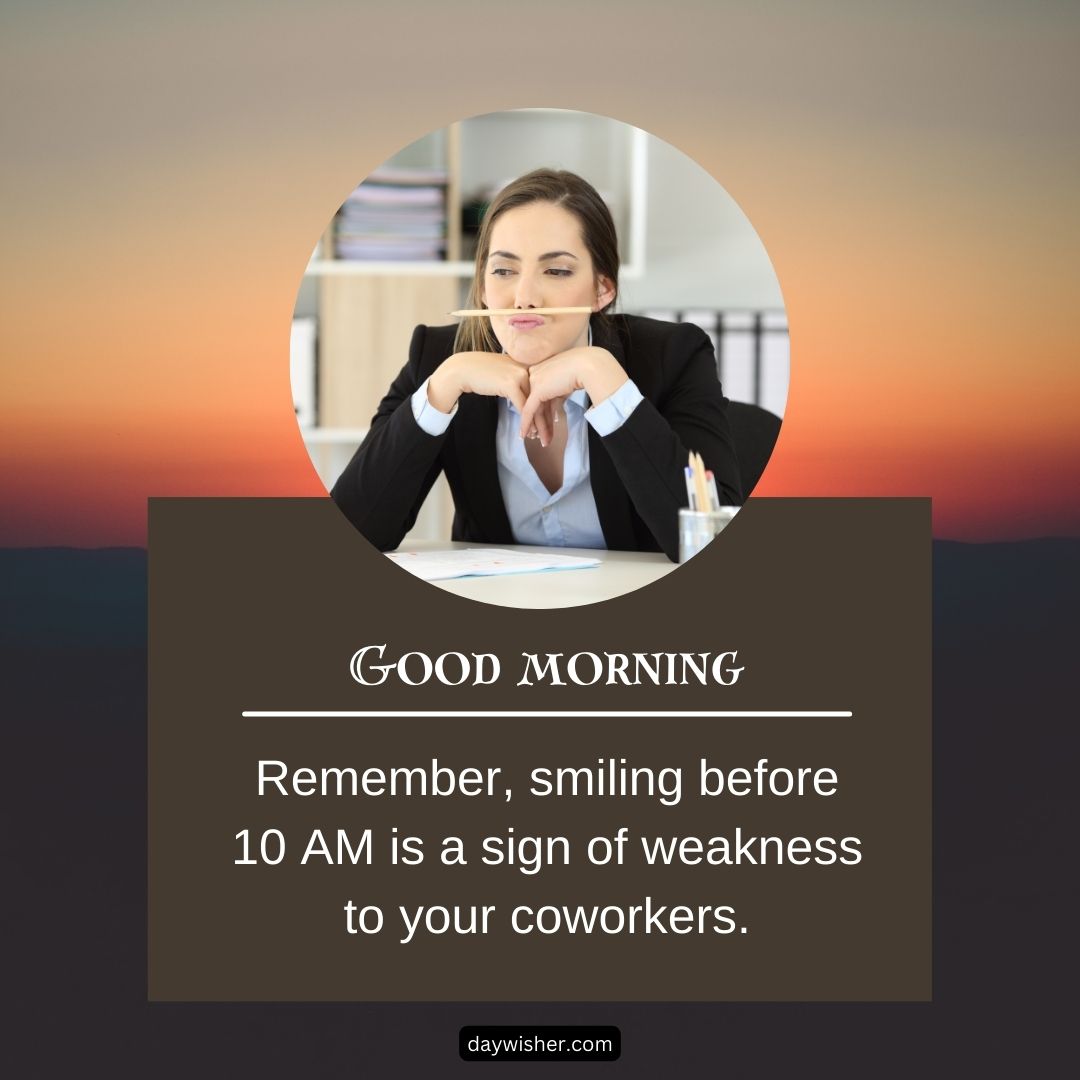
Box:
292, 109, 789, 608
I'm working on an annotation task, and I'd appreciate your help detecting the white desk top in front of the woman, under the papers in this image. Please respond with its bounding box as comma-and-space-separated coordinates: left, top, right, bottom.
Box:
388, 540, 675, 608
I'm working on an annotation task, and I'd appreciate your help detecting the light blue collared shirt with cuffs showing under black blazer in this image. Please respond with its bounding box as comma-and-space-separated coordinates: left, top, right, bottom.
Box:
413, 360, 643, 548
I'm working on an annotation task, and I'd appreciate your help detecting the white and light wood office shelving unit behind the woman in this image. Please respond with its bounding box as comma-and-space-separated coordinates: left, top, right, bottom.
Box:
293, 109, 648, 483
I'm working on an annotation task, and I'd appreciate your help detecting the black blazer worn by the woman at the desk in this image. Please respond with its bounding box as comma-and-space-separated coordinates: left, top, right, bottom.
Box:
330, 315, 742, 561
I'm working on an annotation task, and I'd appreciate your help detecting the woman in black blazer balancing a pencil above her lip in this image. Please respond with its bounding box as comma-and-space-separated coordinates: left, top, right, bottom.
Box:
330, 170, 742, 561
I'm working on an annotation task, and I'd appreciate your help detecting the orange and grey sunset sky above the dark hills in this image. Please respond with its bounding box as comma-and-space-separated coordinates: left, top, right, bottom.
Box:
0, 0, 1080, 545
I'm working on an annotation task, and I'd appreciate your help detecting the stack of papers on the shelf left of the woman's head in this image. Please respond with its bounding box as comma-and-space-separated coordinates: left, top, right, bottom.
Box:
334, 166, 447, 261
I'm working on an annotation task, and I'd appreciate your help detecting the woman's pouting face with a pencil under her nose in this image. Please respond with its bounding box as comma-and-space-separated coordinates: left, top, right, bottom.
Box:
482, 202, 615, 364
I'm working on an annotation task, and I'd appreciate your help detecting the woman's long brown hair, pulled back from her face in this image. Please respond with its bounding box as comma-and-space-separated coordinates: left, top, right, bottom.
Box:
454, 168, 619, 352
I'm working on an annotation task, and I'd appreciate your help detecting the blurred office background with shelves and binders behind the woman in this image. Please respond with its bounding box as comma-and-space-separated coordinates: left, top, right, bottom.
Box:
292, 109, 789, 539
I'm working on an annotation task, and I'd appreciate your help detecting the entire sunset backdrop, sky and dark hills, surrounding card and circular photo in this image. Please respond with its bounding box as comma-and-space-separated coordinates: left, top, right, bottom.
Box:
0, 0, 1080, 1080
